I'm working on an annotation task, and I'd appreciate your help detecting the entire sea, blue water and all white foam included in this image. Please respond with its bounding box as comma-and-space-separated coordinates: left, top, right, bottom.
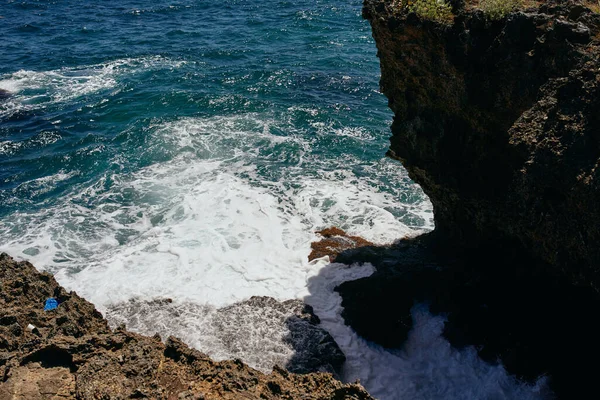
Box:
0, 0, 545, 399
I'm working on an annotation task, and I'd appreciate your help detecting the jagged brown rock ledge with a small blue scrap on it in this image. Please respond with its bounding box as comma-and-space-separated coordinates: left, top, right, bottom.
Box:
0, 254, 371, 399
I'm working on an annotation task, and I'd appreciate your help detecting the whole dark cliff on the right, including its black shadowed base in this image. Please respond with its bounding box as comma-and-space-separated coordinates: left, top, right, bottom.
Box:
337, 0, 600, 398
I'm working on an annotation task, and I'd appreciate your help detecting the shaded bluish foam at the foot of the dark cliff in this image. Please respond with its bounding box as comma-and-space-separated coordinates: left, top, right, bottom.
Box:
305, 264, 549, 400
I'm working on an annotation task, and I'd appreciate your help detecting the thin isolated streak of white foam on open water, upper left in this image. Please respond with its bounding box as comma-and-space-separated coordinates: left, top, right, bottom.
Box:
0, 56, 185, 118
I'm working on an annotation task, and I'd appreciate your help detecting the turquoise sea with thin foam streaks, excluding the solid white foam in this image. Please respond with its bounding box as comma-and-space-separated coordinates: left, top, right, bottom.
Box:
0, 1, 430, 266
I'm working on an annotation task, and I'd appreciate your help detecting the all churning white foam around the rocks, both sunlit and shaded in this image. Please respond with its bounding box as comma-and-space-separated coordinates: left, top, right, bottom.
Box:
0, 114, 545, 399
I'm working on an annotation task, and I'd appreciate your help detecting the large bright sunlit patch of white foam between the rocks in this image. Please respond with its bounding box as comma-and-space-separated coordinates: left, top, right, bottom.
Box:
2, 115, 420, 308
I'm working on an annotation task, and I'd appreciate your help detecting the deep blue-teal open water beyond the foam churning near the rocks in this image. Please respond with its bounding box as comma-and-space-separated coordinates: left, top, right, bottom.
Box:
0, 1, 421, 211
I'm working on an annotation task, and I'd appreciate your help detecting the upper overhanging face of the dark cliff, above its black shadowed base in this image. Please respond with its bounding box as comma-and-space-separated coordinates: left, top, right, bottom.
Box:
364, 0, 600, 289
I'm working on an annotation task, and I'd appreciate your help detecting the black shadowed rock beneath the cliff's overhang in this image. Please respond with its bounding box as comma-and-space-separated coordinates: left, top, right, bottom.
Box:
336, 233, 600, 398
